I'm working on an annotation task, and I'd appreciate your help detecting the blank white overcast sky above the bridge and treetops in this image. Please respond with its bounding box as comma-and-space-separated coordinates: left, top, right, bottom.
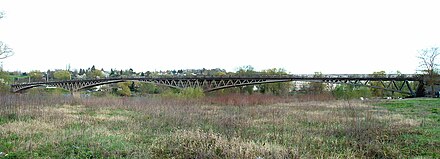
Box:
0, 0, 440, 74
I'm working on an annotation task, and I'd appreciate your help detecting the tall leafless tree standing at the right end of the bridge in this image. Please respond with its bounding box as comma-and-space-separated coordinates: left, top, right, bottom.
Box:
417, 47, 440, 97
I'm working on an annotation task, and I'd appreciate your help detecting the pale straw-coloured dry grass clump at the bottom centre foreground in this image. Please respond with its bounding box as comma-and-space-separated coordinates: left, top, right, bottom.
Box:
150, 130, 291, 158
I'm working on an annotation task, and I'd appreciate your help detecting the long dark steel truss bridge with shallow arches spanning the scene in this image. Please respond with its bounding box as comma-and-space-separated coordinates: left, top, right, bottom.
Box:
11, 74, 425, 97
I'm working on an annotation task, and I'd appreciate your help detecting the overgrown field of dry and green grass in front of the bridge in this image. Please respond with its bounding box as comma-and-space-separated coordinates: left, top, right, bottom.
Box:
0, 95, 440, 158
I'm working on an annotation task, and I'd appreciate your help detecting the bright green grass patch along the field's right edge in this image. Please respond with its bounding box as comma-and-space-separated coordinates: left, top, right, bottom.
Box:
375, 99, 440, 158
